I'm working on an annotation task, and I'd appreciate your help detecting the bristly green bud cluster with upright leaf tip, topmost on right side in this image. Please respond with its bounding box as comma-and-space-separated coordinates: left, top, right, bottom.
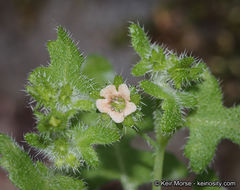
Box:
129, 24, 203, 85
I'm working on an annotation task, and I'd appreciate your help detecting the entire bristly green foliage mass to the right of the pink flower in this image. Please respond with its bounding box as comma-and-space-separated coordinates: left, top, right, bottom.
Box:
129, 21, 240, 181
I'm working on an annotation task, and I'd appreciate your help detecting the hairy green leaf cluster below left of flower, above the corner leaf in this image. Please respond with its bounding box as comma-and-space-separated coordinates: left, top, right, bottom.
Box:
25, 120, 120, 170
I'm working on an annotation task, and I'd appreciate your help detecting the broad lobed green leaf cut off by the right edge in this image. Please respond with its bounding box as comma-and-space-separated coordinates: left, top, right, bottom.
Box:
185, 71, 240, 173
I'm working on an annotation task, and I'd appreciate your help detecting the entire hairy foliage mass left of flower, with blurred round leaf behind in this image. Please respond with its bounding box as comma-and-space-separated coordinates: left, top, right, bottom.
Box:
25, 27, 120, 170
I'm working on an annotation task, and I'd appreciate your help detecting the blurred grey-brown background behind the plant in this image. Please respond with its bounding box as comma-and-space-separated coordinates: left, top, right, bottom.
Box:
0, 0, 240, 190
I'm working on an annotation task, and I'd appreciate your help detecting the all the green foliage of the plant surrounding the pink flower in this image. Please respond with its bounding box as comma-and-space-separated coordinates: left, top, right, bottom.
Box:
0, 24, 240, 190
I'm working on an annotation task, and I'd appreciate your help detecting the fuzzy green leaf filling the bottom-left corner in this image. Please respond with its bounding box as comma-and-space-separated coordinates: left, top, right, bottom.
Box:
0, 134, 85, 190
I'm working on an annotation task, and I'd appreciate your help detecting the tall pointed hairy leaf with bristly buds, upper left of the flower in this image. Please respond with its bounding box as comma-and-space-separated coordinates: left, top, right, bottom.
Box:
26, 27, 96, 113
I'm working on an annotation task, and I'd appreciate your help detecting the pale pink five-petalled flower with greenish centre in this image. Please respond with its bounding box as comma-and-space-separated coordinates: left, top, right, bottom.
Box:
96, 84, 137, 123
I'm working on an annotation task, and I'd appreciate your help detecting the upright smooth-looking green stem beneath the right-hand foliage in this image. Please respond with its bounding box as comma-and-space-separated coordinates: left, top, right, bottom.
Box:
152, 131, 170, 190
